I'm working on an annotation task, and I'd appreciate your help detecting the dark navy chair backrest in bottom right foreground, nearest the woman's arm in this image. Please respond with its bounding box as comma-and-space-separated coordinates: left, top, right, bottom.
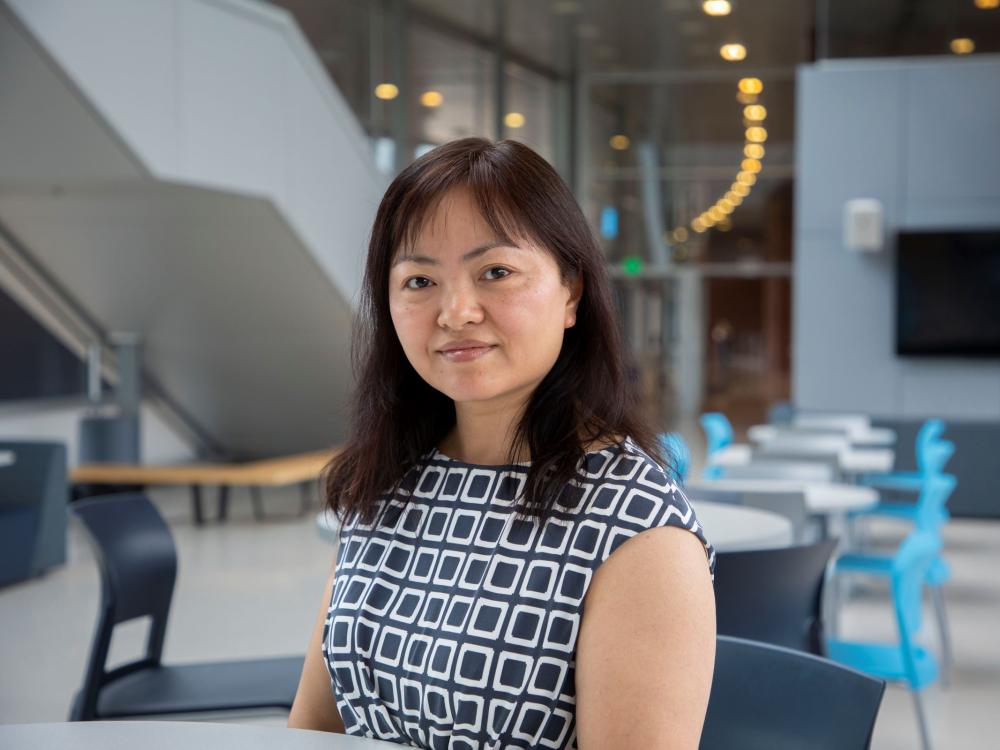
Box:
700, 635, 885, 750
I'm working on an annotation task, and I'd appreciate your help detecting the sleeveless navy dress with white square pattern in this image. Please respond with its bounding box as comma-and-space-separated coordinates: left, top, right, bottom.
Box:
323, 439, 715, 750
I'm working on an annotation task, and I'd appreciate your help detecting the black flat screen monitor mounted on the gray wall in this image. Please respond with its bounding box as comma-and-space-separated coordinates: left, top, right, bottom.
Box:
896, 229, 1000, 357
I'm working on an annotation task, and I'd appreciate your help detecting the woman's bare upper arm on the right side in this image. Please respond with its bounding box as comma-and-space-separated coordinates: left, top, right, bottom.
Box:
576, 527, 715, 750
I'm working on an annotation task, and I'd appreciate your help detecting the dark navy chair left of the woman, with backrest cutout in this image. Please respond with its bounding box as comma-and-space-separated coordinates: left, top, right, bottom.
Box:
69, 494, 304, 721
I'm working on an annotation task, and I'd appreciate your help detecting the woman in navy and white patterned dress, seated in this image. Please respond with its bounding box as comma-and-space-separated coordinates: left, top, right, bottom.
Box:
289, 138, 715, 750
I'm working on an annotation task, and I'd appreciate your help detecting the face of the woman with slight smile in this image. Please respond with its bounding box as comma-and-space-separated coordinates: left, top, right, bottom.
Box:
389, 190, 581, 406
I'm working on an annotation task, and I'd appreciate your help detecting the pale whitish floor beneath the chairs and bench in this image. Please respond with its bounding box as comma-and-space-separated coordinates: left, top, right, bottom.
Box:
0, 484, 1000, 750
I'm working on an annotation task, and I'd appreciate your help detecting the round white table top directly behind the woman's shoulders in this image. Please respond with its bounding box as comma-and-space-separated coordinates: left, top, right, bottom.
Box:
316, 502, 792, 552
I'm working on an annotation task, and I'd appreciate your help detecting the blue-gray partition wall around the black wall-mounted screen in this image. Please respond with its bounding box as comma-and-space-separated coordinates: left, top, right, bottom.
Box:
792, 55, 1000, 515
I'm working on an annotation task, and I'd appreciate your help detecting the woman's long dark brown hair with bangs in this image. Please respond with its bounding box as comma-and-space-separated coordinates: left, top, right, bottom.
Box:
325, 138, 664, 523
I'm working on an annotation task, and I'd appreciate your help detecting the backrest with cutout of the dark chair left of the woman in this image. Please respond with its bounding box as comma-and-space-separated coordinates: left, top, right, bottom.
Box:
72, 493, 177, 719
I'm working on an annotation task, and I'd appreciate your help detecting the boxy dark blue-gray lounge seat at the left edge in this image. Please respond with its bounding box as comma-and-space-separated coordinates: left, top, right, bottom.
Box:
0, 441, 69, 586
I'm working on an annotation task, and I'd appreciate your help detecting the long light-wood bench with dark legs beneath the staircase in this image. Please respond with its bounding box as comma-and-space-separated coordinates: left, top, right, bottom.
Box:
70, 450, 335, 526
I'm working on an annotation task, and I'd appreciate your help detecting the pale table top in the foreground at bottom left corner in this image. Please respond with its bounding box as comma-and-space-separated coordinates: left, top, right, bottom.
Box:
0, 721, 399, 750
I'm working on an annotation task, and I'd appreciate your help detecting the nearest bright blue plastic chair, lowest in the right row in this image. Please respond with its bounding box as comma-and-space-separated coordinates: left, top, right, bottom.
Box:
826, 528, 941, 750
